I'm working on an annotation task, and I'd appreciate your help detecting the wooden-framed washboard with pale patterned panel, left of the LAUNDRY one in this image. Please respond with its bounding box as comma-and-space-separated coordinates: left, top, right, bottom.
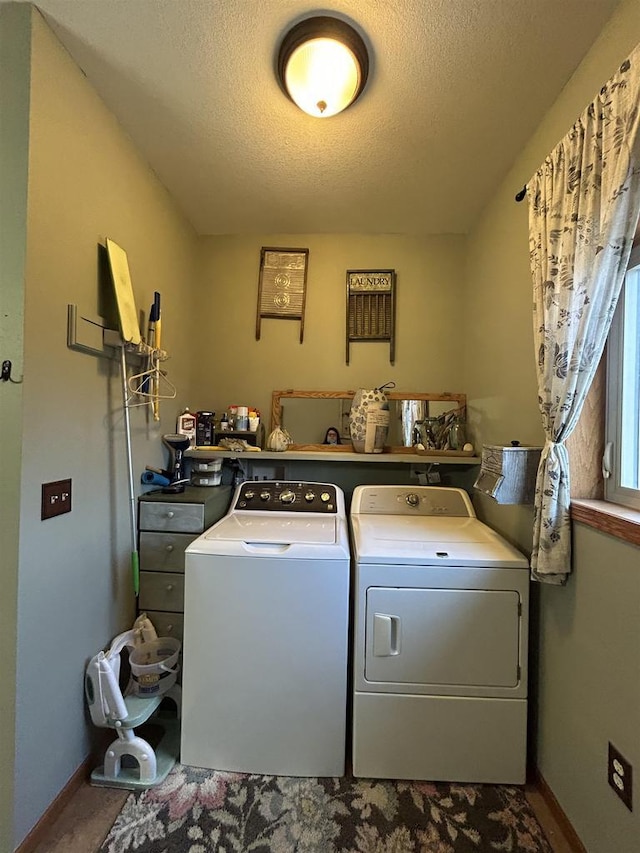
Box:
256, 246, 309, 343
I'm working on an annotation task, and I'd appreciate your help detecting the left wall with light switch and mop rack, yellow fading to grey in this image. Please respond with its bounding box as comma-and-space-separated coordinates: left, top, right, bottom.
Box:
11, 11, 196, 850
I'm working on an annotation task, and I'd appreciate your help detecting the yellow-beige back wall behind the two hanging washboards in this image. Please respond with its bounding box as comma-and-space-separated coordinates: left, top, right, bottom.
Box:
194, 234, 465, 426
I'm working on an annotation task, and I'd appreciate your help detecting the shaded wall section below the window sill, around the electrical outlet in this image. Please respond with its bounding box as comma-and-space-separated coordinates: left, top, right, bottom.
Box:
537, 524, 640, 853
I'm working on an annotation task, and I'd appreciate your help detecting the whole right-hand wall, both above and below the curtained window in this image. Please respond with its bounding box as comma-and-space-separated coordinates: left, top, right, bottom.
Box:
464, 0, 640, 853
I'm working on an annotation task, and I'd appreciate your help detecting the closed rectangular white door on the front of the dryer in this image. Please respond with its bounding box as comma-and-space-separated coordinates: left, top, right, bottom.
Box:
365, 587, 520, 687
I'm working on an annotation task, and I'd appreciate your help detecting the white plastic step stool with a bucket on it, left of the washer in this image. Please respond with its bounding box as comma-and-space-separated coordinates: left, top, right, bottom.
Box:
85, 614, 181, 790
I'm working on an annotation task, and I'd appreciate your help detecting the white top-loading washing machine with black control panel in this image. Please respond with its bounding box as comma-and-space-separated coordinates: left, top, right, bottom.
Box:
181, 481, 350, 776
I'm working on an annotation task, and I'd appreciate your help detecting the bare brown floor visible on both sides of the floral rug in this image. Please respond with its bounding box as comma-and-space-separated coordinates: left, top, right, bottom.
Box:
25, 783, 576, 853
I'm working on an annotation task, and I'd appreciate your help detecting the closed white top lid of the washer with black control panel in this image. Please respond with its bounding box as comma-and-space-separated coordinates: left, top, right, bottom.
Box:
194, 512, 338, 553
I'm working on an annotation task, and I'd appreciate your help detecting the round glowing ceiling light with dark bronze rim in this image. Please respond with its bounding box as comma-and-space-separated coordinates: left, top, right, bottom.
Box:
277, 16, 369, 118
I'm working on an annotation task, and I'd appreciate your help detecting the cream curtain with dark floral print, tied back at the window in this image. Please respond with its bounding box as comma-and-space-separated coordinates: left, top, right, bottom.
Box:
527, 45, 640, 584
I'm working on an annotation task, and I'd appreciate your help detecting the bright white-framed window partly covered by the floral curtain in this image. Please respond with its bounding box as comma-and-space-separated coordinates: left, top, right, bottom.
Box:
603, 244, 640, 509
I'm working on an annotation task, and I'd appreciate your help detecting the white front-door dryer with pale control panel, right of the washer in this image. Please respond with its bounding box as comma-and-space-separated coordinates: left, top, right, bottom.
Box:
350, 486, 529, 784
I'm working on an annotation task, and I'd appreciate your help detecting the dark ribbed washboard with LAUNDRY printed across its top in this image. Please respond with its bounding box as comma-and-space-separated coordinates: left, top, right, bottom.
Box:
347, 270, 396, 364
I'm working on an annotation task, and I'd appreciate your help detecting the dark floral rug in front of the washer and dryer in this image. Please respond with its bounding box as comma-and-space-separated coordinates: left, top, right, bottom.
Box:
100, 764, 552, 853
